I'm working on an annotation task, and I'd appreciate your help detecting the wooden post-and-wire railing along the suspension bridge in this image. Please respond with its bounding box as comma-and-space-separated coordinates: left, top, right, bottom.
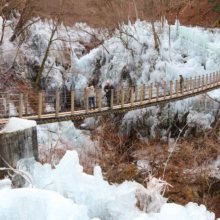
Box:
0, 71, 220, 118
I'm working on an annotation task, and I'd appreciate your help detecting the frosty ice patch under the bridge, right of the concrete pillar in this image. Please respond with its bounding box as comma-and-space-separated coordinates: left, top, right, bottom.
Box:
37, 121, 99, 164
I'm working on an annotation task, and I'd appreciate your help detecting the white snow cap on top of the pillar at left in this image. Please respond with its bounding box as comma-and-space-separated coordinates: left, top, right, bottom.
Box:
0, 118, 37, 133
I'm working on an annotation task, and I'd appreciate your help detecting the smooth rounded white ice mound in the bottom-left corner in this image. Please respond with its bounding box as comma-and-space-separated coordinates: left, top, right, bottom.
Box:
0, 189, 90, 220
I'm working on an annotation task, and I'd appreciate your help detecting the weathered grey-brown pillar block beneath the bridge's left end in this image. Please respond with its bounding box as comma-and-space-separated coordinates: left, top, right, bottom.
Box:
0, 119, 38, 179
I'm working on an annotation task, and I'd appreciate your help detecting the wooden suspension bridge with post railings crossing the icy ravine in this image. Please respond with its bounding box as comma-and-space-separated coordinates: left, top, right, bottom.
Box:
0, 71, 220, 126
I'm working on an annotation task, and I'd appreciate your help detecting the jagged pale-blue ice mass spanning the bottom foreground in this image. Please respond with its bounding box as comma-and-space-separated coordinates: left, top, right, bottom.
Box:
0, 151, 215, 220
